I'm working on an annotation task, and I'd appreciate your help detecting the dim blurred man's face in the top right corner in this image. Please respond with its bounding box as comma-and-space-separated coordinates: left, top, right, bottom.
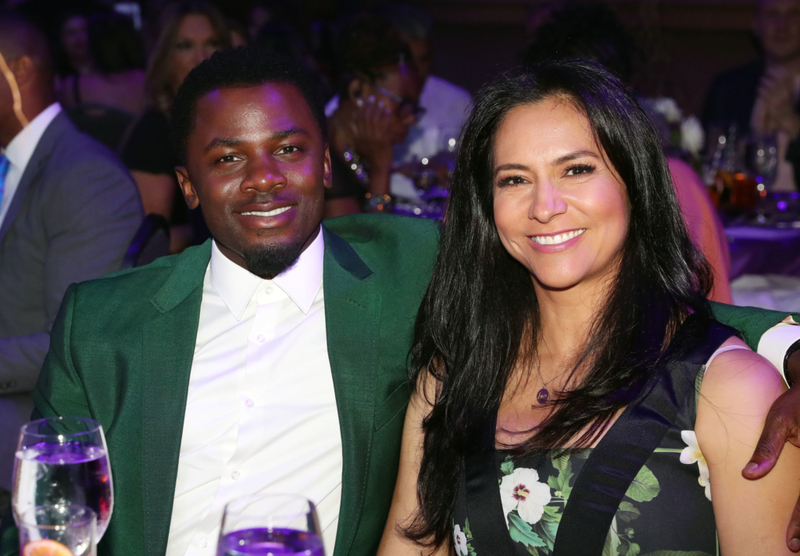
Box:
756, 0, 800, 62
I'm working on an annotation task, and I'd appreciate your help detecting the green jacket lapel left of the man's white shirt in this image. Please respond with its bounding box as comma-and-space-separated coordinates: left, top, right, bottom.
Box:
142, 241, 211, 556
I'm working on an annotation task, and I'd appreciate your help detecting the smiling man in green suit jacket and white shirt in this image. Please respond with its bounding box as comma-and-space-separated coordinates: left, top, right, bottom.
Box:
0, 49, 791, 556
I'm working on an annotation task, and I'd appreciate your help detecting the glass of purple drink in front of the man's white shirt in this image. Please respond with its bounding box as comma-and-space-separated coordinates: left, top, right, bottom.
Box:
217, 494, 325, 556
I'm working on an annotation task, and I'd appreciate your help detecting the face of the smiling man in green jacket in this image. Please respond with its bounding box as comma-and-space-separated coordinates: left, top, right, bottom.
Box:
178, 83, 331, 278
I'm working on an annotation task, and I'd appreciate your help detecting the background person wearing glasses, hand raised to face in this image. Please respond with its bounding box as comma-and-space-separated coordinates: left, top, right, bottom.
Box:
325, 15, 425, 218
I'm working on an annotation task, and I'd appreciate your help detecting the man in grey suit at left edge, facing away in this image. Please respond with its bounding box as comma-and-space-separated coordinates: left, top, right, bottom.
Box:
0, 15, 143, 490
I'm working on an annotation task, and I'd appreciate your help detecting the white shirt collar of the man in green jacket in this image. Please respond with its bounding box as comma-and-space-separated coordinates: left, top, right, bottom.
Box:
210, 228, 325, 321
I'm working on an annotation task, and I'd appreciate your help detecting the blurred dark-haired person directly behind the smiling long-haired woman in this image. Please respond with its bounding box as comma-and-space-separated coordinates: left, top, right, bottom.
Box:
523, 2, 731, 303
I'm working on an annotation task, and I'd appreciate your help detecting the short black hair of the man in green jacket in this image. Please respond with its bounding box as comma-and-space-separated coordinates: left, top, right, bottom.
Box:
170, 47, 328, 164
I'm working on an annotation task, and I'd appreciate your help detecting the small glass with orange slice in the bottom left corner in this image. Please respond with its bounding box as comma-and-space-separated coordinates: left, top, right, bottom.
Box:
19, 505, 97, 556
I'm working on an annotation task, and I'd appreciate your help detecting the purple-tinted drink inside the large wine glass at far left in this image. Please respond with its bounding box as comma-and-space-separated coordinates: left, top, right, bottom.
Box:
14, 441, 114, 539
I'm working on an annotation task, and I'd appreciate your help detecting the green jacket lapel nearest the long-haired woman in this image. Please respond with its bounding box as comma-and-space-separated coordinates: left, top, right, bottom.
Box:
323, 227, 381, 554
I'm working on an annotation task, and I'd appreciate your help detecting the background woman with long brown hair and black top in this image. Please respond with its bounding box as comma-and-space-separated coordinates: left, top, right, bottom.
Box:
121, 0, 230, 253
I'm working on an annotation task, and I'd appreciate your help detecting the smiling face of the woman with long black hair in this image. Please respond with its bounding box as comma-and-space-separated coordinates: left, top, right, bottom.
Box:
493, 98, 630, 291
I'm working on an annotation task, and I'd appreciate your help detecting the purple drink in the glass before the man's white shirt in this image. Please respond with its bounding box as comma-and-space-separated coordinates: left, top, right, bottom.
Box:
217, 528, 325, 556
